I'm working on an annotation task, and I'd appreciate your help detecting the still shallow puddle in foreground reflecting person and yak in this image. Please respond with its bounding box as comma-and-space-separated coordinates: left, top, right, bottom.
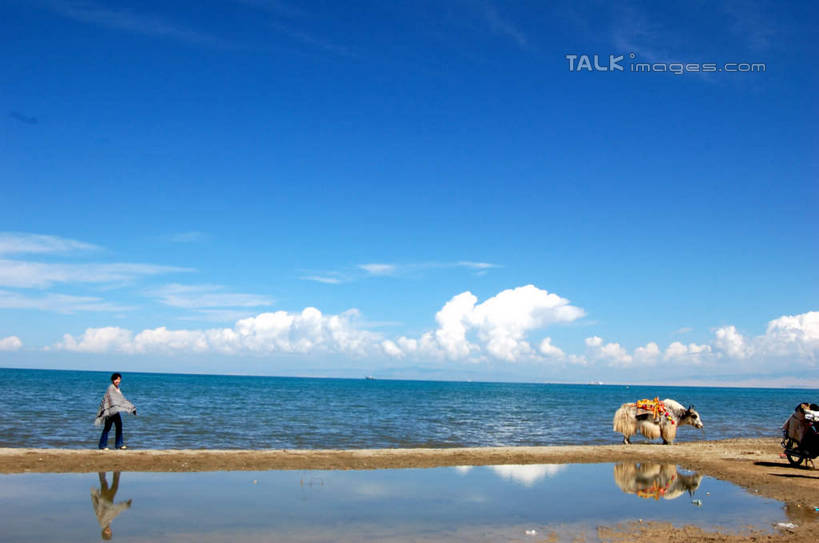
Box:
0, 464, 788, 542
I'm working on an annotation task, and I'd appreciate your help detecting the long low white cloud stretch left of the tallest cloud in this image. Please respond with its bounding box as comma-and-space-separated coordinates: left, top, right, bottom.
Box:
54, 307, 382, 356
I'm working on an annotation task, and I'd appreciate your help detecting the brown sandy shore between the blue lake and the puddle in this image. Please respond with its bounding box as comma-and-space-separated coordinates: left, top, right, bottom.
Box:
0, 438, 819, 542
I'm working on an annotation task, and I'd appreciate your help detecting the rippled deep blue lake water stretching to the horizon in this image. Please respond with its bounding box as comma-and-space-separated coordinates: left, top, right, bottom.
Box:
0, 369, 819, 449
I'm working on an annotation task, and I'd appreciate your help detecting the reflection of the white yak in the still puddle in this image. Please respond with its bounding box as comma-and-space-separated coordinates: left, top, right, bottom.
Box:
614, 464, 702, 500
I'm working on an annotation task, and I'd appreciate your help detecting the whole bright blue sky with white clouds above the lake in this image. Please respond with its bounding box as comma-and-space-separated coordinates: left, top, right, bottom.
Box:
0, 0, 819, 385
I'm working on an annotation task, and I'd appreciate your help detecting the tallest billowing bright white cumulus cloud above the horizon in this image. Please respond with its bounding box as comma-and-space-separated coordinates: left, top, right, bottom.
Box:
390, 285, 585, 362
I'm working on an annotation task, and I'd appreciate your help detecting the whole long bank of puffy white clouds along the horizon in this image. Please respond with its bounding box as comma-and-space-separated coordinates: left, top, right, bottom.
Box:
48, 285, 819, 369
